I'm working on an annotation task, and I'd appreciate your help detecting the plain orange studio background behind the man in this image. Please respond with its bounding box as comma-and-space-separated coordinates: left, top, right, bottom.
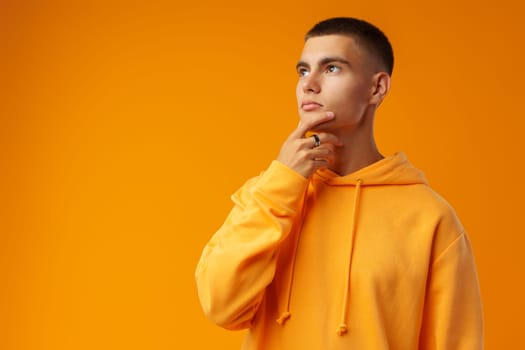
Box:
0, 0, 525, 350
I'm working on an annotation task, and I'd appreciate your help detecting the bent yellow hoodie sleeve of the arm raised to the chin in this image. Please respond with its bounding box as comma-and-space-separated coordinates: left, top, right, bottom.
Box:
195, 161, 308, 329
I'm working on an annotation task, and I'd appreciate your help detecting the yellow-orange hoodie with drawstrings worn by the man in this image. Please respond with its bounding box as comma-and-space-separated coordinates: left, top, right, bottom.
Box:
196, 153, 483, 350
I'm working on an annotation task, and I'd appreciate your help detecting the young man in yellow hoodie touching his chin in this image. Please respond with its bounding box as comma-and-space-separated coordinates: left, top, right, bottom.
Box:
196, 18, 483, 350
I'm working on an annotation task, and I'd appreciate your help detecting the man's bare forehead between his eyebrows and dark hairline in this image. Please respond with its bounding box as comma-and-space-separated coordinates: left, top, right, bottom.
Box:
301, 34, 362, 63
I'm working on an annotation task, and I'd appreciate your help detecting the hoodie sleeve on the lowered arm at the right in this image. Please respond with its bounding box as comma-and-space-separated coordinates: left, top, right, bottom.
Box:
419, 233, 483, 350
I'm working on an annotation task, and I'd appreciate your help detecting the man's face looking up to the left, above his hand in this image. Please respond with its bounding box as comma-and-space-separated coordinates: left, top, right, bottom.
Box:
296, 35, 374, 131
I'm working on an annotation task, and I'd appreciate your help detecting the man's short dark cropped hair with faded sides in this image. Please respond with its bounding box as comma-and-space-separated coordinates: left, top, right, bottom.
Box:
305, 17, 394, 75
